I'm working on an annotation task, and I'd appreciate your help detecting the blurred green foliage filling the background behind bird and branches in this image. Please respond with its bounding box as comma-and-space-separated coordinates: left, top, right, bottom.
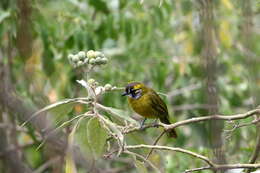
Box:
0, 0, 260, 173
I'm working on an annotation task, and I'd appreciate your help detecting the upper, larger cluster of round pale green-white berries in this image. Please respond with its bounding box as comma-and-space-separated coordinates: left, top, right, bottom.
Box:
68, 50, 108, 67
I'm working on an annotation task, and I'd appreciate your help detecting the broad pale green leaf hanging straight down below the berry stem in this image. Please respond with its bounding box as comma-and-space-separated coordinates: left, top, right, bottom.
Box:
87, 117, 108, 159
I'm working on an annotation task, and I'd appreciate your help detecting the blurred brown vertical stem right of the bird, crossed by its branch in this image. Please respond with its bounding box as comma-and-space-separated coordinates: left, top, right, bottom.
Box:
200, 0, 227, 168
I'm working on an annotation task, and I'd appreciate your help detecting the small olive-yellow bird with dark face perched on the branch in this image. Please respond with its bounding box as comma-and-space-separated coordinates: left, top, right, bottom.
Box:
122, 82, 177, 138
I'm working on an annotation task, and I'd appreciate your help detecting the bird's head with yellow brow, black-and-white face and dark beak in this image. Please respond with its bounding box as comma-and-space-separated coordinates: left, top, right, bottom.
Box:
122, 82, 149, 99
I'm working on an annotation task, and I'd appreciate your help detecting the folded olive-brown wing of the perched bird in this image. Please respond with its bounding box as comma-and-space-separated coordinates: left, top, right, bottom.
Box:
149, 91, 168, 117
